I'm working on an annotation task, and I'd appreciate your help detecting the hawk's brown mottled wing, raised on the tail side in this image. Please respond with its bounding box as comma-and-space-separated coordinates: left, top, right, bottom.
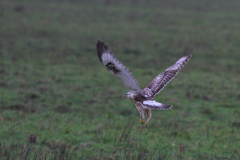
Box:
143, 48, 193, 98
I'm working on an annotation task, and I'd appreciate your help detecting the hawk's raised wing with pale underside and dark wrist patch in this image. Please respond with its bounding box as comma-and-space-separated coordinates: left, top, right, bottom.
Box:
97, 41, 141, 93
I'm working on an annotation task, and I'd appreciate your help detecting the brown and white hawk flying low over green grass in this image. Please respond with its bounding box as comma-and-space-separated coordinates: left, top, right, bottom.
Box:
96, 41, 193, 126
